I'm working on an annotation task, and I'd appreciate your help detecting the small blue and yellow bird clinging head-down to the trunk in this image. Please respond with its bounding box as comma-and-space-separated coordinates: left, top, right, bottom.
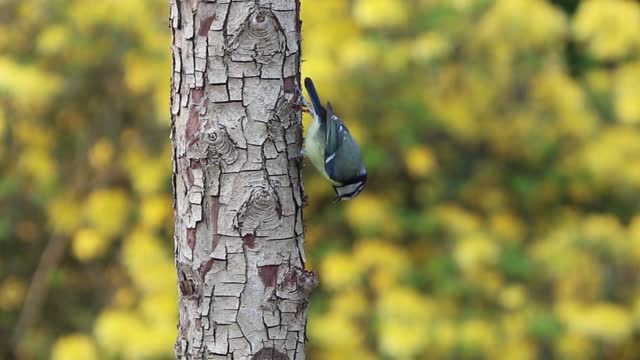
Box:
302, 78, 367, 201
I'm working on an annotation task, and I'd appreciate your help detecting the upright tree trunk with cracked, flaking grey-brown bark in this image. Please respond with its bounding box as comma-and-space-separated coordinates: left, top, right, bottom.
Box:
169, 0, 317, 359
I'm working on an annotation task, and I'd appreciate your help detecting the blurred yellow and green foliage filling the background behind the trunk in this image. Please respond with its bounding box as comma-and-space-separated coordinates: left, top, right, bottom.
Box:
0, 0, 640, 360
